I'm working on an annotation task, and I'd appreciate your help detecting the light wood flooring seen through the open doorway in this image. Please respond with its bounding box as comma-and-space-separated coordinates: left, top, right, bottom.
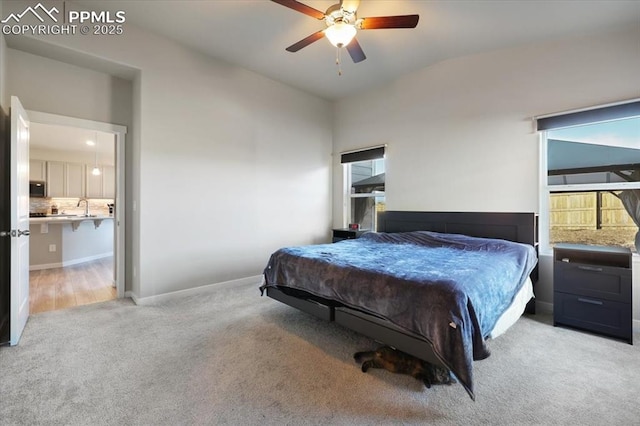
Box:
29, 258, 117, 314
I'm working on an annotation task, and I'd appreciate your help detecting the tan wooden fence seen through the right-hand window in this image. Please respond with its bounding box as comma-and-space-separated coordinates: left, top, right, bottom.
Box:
549, 191, 636, 229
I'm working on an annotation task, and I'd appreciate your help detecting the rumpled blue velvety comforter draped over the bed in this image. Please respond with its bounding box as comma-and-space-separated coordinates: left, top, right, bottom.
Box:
264, 231, 537, 399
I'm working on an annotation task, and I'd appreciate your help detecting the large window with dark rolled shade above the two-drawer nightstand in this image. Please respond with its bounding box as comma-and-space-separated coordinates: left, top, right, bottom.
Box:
538, 102, 640, 252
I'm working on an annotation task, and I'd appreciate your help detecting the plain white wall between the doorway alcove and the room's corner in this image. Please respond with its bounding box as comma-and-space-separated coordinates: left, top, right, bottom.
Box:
5, 2, 332, 298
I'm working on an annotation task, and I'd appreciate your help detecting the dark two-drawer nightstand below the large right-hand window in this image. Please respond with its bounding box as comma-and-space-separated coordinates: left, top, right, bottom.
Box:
553, 244, 633, 344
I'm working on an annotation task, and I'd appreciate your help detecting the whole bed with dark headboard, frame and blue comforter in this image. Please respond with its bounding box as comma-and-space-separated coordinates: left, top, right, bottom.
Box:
260, 211, 537, 400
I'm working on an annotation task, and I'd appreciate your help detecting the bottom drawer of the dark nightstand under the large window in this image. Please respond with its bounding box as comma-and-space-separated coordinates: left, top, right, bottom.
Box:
553, 292, 633, 343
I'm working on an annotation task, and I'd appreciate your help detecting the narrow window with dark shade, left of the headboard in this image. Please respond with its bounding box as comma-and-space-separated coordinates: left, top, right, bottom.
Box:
341, 147, 385, 230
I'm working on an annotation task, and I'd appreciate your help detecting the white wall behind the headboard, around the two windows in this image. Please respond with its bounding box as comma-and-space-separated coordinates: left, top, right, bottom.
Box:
333, 28, 640, 318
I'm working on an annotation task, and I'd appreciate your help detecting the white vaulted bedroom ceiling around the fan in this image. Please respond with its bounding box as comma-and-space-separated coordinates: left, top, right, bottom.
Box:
74, 0, 640, 99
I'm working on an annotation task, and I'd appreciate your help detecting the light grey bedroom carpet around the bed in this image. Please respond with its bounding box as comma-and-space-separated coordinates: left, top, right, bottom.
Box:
0, 283, 640, 425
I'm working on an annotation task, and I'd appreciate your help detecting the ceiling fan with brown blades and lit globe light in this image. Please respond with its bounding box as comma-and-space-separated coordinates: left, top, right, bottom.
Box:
271, 0, 420, 63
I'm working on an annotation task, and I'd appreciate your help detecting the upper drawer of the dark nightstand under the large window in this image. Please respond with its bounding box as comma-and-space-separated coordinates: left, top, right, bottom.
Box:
553, 262, 631, 303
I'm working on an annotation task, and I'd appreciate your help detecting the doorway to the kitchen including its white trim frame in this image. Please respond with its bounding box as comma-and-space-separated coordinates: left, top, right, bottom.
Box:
28, 111, 126, 313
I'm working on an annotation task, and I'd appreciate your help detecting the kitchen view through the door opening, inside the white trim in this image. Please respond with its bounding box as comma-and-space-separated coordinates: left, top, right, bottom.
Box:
29, 122, 117, 313
